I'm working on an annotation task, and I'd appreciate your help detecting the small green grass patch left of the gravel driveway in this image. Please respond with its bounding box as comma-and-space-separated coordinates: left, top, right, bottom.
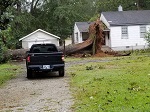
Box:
0, 63, 20, 86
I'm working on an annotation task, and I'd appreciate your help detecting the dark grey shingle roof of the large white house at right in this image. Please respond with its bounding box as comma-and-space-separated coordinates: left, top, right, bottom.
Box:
102, 10, 150, 26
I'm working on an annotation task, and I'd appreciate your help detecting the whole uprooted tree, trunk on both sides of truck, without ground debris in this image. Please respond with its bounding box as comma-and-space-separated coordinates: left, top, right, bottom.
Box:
9, 20, 104, 59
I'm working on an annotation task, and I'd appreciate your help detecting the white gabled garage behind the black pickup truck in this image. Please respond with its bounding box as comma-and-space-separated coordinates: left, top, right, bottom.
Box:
19, 29, 60, 49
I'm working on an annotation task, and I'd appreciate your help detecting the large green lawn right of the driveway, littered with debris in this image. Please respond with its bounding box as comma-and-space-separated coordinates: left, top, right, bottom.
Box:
67, 55, 150, 112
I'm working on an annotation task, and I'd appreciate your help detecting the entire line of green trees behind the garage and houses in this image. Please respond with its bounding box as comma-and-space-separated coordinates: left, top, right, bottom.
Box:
0, 0, 150, 49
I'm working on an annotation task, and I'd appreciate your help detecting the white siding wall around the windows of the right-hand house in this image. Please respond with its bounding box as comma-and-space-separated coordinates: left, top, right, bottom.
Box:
109, 25, 150, 51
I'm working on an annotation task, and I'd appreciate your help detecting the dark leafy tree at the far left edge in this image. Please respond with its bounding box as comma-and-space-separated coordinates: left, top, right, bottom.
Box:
0, 0, 15, 63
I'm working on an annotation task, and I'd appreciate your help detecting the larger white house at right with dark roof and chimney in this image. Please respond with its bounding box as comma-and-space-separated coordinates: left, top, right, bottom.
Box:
100, 8, 150, 51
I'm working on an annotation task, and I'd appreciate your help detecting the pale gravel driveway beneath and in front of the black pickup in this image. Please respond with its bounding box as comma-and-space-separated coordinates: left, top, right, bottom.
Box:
0, 63, 73, 112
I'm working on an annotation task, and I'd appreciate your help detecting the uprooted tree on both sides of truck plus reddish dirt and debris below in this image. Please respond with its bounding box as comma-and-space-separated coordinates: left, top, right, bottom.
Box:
9, 19, 131, 60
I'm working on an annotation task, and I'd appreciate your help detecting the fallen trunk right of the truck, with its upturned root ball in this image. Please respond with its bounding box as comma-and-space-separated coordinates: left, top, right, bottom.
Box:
59, 19, 104, 55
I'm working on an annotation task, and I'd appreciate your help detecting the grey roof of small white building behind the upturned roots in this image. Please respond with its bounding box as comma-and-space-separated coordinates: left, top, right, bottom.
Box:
75, 22, 93, 32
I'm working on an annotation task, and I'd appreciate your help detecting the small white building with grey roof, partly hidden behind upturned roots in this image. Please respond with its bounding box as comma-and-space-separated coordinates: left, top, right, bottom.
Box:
73, 22, 92, 43
